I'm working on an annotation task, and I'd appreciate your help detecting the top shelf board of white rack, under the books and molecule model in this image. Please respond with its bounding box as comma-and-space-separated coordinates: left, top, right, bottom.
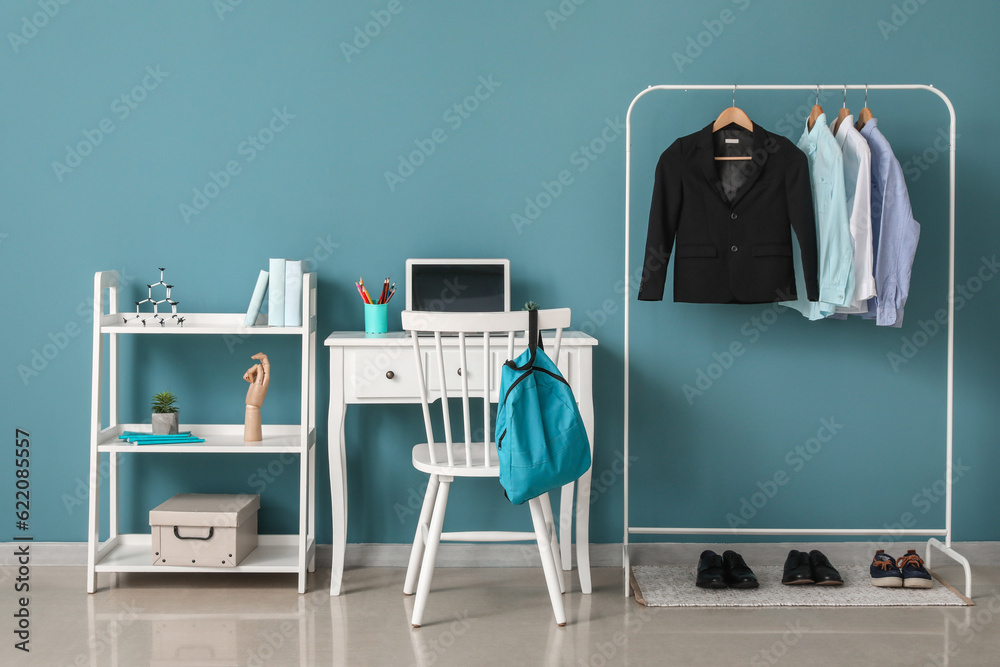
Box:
101, 313, 316, 336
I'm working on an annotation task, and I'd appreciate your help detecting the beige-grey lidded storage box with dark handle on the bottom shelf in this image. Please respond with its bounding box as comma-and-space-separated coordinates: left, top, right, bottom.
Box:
149, 493, 260, 567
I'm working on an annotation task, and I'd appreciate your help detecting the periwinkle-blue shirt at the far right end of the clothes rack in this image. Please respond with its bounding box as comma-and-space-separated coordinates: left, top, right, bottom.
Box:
861, 118, 920, 327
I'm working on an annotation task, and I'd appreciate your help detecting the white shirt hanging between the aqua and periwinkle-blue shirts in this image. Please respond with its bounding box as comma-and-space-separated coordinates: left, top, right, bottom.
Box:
830, 115, 875, 314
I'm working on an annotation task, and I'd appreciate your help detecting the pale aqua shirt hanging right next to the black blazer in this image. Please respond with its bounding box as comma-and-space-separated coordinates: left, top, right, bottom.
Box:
782, 114, 854, 320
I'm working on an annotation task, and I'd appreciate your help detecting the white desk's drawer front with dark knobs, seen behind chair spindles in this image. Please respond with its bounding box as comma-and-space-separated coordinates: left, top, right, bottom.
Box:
344, 345, 576, 401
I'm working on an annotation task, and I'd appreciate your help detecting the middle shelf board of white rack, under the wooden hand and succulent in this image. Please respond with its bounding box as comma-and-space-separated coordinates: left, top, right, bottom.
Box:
97, 424, 316, 454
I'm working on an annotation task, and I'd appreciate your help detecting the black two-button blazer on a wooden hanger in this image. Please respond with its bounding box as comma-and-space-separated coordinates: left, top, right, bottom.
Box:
639, 123, 819, 303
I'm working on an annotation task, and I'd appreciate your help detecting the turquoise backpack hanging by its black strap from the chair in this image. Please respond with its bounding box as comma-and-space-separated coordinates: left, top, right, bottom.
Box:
496, 310, 590, 505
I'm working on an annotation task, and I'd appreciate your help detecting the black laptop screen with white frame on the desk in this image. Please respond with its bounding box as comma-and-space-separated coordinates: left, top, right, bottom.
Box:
406, 259, 510, 313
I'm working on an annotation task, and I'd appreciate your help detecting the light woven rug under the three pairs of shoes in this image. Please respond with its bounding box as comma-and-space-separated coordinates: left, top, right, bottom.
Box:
632, 565, 975, 607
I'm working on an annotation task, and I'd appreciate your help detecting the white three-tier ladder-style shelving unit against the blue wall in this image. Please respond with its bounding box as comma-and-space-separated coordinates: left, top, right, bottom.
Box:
87, 271, 316, 593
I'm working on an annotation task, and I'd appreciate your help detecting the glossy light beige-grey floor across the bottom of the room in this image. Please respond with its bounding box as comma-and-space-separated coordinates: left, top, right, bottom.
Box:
7, 566, 1000, 667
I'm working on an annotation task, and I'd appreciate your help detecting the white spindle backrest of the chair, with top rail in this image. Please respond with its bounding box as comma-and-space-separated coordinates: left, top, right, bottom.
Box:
402, 308, 572, 467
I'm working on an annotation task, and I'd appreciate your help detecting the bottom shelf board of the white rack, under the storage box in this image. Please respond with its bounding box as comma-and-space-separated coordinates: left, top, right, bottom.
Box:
95, 534, 316, 574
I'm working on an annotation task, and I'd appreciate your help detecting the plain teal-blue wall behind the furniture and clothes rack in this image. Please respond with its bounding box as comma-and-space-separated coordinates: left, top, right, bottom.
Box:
0, 0, 1000, 542
